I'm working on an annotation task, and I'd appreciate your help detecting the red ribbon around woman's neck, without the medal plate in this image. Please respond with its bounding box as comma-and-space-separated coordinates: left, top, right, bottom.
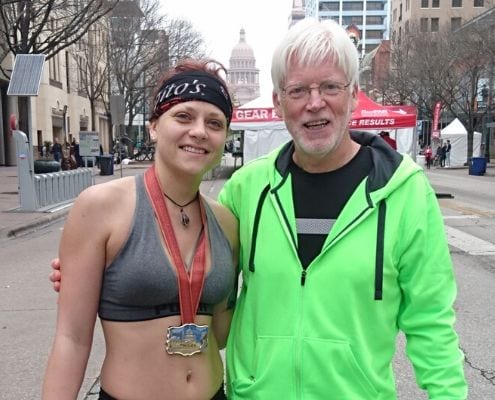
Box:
144, 166, 206, 324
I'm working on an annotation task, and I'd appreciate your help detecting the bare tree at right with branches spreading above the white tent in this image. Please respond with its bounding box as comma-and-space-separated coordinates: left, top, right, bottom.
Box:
386, 22, 489, 161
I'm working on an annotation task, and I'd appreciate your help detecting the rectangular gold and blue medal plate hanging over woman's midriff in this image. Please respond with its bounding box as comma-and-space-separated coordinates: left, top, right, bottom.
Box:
165, 324, 208, 356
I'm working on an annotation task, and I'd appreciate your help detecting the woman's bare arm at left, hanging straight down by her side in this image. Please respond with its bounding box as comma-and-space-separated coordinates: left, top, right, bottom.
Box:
43, 185, 111, 400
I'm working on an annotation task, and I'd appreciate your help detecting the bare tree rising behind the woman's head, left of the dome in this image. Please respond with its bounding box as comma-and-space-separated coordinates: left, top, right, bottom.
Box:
110, 0, 204, 141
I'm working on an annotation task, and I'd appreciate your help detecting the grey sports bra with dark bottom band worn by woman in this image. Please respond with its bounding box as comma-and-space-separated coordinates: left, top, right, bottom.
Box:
98, 174, 236, 321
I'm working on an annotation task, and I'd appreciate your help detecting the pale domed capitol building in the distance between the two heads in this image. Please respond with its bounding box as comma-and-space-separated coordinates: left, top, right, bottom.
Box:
227, 28, 260, 107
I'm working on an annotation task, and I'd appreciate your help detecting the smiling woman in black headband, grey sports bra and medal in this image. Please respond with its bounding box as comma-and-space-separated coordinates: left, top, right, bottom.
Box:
43, 60, 238, 400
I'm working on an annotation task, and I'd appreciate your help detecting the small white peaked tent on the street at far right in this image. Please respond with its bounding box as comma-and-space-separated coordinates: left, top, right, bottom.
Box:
442, 118, 481, 167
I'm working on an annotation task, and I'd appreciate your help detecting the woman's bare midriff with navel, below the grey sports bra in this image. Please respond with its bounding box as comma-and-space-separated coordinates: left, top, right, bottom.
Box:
101, 315, 223, 400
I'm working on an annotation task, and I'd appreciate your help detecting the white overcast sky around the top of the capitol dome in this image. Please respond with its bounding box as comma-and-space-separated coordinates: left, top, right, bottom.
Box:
160, 0, 293, 96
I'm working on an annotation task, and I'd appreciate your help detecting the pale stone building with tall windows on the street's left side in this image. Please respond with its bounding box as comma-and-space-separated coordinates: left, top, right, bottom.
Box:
0, 0, 145, 165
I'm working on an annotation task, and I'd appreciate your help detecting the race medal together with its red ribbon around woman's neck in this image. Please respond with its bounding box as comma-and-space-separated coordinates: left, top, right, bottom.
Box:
144, 166, 208, 356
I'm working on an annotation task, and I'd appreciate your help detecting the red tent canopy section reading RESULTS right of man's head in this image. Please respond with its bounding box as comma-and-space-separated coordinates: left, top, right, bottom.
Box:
349, 91, 416, 130
